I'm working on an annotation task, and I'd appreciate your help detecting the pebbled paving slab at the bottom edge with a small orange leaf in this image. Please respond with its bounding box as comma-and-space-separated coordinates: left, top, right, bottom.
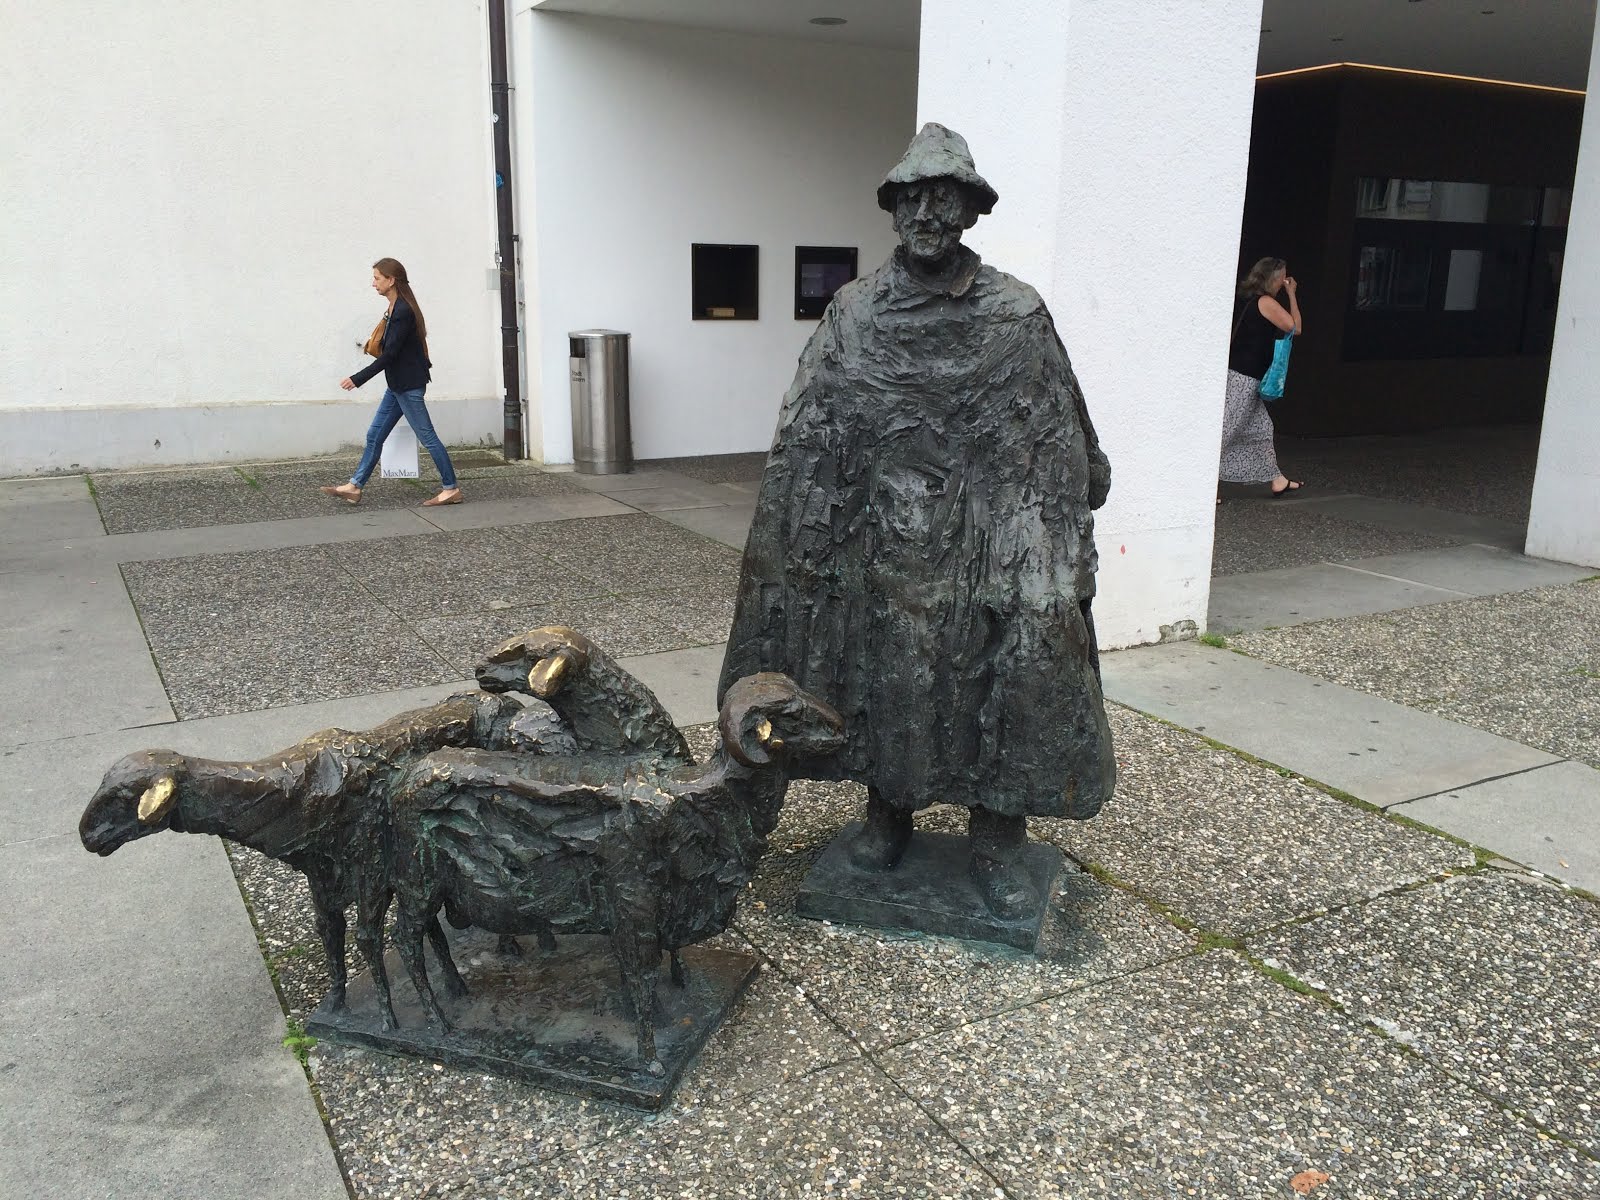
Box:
878, 954, 1594, 1200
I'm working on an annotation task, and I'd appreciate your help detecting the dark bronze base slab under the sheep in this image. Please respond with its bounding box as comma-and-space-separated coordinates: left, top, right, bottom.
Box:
306, 930, 758, 1110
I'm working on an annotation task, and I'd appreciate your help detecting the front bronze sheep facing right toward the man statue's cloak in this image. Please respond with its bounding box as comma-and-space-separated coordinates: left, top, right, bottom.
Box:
384, 662, 843, 1070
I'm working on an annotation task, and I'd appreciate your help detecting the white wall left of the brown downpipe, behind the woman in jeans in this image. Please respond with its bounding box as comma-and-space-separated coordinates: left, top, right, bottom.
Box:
0, 0, 499, 474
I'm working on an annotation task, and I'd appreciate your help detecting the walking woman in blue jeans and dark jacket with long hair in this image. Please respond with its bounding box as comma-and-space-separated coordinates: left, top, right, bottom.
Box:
323, 258, 461, 509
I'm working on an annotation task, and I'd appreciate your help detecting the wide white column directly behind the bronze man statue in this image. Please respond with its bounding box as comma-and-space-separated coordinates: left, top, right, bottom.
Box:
917, 0, 1261, 646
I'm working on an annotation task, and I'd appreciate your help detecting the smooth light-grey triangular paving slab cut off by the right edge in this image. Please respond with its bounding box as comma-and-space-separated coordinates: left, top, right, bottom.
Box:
1390, 763, 1600, 891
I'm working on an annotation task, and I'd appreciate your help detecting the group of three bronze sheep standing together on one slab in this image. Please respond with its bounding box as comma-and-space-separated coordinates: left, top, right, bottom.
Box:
78, 626, 843, 1072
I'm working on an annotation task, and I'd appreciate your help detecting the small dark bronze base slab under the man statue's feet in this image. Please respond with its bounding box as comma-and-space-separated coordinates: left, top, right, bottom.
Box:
795, 821, 1061, 954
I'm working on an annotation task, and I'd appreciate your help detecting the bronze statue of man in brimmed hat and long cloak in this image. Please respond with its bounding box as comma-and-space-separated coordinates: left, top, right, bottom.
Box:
722, 123, 1115, 918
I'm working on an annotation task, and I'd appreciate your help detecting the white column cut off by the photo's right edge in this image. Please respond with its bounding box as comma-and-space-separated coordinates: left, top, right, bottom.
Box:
1528, 28, 1600, 566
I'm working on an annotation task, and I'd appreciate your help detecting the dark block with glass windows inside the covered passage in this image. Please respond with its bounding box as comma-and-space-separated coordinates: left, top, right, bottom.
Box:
1240, 66, 1584, 437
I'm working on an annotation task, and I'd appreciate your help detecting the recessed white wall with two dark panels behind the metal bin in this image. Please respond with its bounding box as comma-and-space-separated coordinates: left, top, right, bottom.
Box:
517, 11, 917, 462
